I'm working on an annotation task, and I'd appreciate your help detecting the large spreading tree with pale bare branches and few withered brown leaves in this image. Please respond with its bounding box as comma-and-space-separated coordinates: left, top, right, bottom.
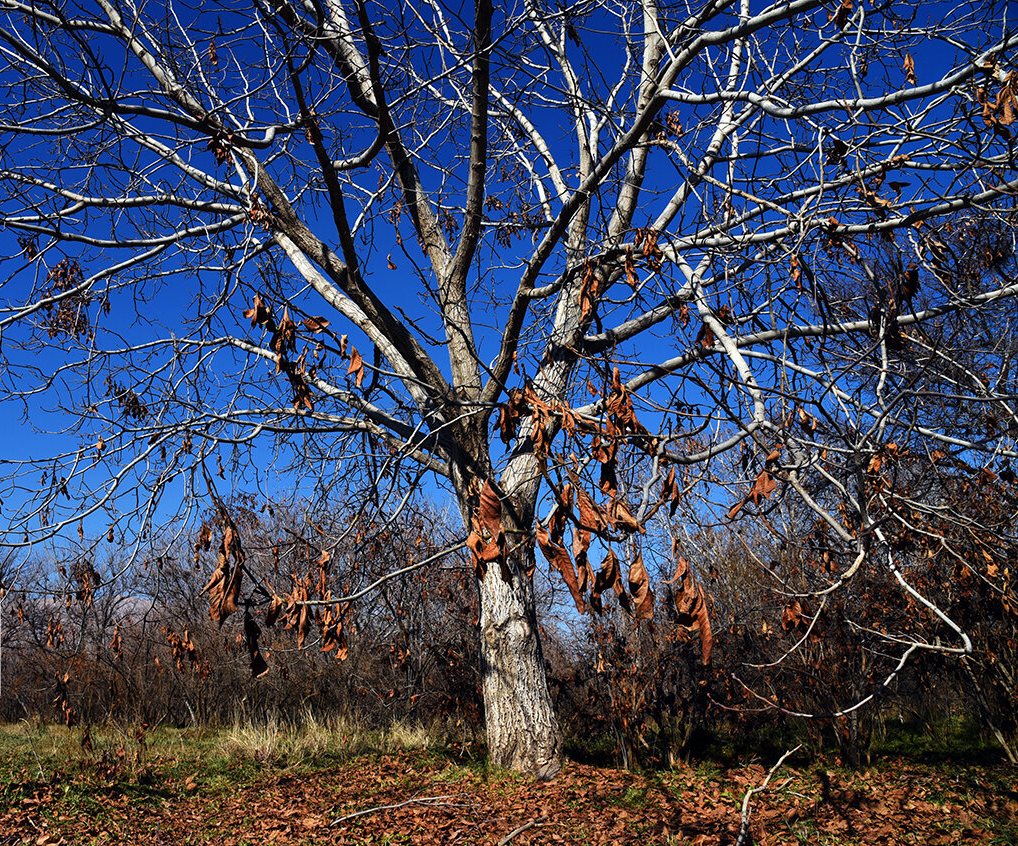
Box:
0, 0, 1018, 776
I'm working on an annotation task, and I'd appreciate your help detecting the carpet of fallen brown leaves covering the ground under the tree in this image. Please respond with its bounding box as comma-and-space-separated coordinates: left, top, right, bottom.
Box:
0, 753, 1018, 846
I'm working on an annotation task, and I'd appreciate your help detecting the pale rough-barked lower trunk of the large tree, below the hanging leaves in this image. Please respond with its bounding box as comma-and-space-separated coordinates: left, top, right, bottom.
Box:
478, 542, 562, 779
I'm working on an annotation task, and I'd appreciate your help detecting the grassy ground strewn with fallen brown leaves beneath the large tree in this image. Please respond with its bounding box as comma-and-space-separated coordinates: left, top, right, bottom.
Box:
0, 727, 1018, 846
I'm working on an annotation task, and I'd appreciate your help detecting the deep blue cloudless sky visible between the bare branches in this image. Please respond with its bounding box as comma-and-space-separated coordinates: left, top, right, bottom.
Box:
0, 3, 1013, 578
